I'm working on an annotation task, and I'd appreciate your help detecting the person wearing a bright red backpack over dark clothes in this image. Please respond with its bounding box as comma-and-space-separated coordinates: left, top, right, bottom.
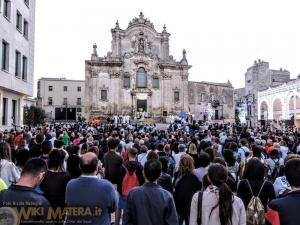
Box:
115, 147, 145, 225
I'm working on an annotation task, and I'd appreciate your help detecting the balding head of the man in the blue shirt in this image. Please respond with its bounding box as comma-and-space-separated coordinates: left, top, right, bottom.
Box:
79, 152, 98, 176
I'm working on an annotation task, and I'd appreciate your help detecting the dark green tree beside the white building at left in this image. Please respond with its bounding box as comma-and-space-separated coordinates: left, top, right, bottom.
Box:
24, 106, 45, 126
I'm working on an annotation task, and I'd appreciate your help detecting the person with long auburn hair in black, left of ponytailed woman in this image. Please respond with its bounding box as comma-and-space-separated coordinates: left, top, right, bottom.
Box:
174, 154, 202, 225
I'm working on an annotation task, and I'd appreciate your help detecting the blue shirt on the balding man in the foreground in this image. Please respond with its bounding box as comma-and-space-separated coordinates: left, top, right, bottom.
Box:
66, 176, 117, 225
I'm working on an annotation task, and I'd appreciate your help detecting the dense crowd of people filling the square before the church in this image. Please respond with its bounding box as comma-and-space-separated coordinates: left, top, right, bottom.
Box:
0, 121, 300, 225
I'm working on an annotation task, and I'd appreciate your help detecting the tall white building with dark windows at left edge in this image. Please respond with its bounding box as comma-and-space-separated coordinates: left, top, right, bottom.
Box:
0, 0, 35, 127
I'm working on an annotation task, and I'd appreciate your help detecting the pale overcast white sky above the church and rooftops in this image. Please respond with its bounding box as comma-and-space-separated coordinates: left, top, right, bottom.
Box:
35, 0, 300, 93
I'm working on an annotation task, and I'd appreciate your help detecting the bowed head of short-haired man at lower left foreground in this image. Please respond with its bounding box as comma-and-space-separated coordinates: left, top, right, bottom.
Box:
19, 158, 47, 188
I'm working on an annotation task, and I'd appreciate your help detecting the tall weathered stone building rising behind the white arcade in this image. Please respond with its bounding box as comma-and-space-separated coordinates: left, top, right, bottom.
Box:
235, 59, 290, 126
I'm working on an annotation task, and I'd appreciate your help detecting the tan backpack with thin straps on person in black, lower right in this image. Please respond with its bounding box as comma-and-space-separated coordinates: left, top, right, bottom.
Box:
246, 180, 265, 225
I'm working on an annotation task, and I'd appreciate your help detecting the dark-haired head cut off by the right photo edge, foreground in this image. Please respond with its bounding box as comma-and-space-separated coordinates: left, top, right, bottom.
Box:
284, 158, 300, 188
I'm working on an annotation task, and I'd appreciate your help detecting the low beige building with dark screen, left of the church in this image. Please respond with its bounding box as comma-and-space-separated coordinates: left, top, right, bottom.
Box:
37, 78, 85, 121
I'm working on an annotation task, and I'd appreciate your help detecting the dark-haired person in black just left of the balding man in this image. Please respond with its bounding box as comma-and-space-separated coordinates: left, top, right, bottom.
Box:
40, 149, 69, 224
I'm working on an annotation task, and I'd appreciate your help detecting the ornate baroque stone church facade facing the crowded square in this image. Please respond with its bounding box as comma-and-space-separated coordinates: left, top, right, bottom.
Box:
84, 13, 234, 119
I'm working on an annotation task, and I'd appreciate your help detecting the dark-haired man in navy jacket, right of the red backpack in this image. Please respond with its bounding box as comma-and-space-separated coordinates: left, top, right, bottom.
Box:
123, 159, 178, 225
